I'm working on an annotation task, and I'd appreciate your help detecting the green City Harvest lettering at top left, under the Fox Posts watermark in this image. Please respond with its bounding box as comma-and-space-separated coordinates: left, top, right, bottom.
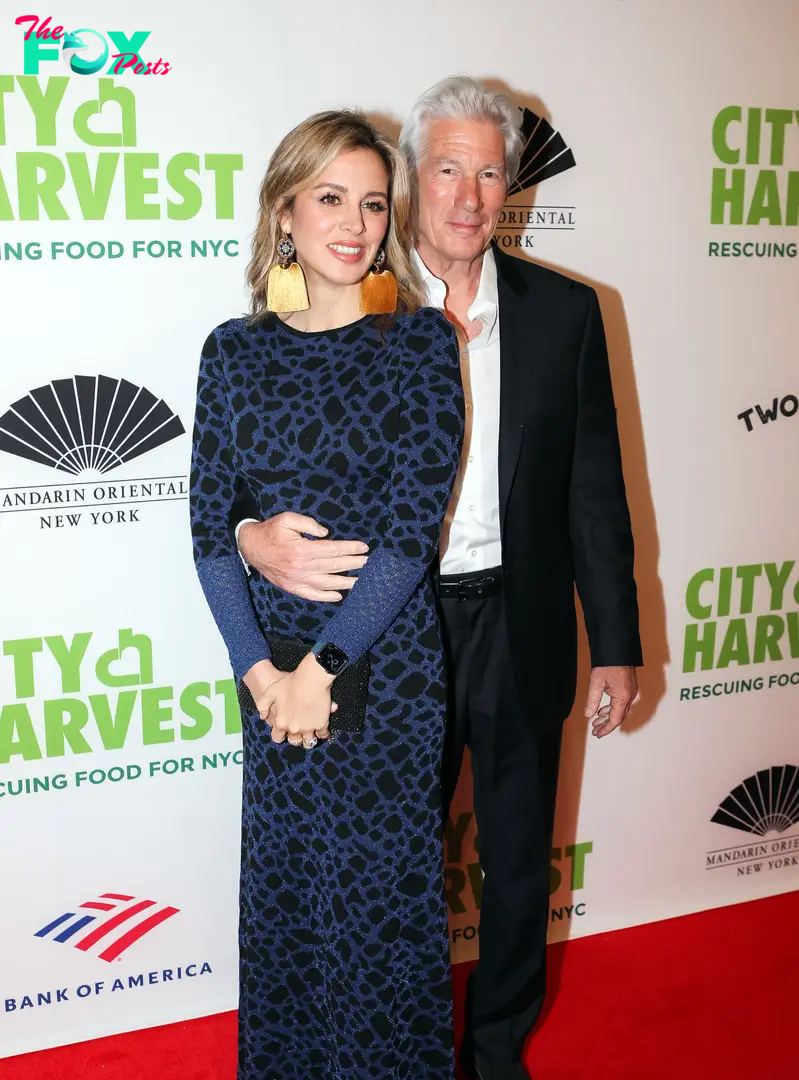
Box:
0, 75, 244, 221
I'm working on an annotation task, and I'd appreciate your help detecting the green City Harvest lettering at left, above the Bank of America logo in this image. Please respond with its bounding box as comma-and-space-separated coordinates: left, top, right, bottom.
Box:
0, 629, 242, 765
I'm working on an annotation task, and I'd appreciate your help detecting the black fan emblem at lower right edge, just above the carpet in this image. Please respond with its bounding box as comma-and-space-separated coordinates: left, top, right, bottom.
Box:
710, 765, 799, 836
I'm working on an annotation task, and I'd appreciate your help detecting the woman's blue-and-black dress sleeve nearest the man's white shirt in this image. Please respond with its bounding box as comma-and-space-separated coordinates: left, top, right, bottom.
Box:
316, 310, 463, 662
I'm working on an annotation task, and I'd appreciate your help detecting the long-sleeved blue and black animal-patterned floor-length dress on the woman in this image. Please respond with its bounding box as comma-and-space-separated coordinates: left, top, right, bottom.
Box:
191, 308, 463, 1080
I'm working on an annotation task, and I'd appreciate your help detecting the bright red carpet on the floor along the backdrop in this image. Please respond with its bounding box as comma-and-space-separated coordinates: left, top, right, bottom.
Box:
0, 892, 799, 1080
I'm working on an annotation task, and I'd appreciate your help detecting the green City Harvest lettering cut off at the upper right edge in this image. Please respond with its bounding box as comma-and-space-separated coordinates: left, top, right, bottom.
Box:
710, 105, 799, 226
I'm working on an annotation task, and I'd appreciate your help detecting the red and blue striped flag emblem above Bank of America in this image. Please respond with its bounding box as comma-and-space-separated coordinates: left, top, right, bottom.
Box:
33, 892, 180, 963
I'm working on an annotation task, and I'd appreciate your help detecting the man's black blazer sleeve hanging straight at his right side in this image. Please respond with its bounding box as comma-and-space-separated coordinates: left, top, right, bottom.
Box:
569, 289, 642, 667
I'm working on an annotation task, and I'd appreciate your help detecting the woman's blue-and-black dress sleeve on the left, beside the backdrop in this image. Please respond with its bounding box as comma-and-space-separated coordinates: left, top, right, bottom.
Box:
189, 328, 270, 678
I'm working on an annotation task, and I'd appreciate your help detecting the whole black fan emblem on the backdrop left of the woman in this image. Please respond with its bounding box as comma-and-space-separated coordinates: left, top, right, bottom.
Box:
0, 375, 185, 476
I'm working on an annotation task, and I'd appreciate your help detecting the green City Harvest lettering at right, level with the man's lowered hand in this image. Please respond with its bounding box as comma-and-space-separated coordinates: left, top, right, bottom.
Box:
682, 559, 799, 672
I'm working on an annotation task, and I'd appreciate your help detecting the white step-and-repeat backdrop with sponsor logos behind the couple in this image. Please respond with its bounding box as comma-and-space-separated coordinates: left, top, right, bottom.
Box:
0, 0, 799, 1054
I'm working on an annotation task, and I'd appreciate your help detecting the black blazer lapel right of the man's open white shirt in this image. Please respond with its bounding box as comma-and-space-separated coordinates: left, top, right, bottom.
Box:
495, 247, 534, 525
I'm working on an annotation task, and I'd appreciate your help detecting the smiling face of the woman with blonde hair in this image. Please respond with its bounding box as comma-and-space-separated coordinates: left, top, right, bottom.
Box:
280, 149, 389, 286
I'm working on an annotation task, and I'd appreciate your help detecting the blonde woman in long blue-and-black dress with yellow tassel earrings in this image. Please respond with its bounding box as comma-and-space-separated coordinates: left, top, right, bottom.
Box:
191, 112, 463, 1080
